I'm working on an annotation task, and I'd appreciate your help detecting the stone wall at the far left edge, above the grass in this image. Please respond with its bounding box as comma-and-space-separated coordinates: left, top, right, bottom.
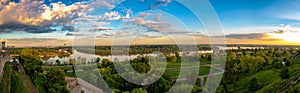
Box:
0, 51, 10, 82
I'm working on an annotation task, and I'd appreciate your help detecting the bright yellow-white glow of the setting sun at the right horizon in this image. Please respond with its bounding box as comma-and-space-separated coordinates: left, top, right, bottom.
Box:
269, 31, 300, 43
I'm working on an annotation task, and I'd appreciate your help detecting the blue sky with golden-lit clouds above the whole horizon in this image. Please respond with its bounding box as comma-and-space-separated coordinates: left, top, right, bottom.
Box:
0, 0, 300, 47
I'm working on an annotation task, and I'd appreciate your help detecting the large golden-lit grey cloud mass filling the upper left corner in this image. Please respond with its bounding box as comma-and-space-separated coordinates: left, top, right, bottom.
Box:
0, 0, 92, 33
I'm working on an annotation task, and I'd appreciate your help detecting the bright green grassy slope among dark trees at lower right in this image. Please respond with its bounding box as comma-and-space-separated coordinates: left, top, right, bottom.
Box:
229, 70, 280, 93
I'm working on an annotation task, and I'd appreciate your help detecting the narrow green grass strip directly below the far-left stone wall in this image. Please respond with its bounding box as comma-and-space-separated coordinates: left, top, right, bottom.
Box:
0, 62, 12, 93
